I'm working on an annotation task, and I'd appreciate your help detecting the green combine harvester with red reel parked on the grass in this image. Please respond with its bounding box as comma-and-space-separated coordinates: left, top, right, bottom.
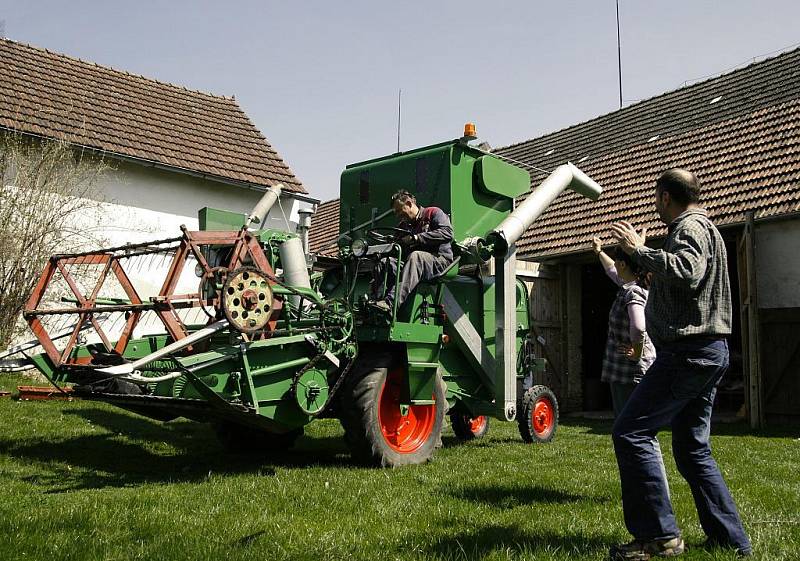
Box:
12, 127, 601, 466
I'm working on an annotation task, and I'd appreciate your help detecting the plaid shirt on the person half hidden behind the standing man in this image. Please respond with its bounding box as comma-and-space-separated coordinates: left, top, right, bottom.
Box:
600, 282, 655, 384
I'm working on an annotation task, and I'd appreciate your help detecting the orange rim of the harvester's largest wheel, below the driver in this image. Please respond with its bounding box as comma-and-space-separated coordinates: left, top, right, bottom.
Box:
378, 368, 436, 454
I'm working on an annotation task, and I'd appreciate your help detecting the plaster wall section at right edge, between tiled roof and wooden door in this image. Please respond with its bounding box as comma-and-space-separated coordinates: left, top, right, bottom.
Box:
755, 219, 800, 308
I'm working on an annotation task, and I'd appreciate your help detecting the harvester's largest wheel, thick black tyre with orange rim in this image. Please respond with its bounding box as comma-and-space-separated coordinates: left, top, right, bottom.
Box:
341, 365, 446, 467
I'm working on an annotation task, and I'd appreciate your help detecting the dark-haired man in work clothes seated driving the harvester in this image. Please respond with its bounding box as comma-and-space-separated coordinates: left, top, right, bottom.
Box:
373, 189, 453, 313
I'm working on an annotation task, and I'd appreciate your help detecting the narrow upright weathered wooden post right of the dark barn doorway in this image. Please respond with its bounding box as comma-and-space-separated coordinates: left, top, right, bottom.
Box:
737, 212, 764, 428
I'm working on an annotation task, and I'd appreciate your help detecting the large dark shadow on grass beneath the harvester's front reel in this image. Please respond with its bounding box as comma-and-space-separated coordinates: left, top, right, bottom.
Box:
0, 402, 357, 493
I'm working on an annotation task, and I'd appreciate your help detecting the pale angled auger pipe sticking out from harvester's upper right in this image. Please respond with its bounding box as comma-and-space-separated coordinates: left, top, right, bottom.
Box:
486, 162, 603, 255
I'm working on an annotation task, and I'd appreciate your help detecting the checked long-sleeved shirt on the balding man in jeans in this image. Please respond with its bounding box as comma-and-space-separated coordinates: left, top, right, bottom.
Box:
632, 208, 732, 347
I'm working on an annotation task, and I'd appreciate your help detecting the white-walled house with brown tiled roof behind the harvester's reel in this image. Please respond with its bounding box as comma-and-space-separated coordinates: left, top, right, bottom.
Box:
0, 35, 318, 245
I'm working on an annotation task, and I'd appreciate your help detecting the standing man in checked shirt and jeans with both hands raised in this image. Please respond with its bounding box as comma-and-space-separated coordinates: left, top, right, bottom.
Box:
611, 169, 752, 560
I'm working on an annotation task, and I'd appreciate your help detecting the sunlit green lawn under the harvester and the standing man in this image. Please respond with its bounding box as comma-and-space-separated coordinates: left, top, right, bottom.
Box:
0, 375, 800, 561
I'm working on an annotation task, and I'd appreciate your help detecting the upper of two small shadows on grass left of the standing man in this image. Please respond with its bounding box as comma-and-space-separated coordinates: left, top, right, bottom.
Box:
446, 484, 608, 508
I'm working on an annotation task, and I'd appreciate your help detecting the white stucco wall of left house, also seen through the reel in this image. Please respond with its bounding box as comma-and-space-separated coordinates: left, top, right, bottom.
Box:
43, 162, 311, 342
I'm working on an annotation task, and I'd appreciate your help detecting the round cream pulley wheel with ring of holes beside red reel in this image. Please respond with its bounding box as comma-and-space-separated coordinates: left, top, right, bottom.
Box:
222, 267, 272, 333
